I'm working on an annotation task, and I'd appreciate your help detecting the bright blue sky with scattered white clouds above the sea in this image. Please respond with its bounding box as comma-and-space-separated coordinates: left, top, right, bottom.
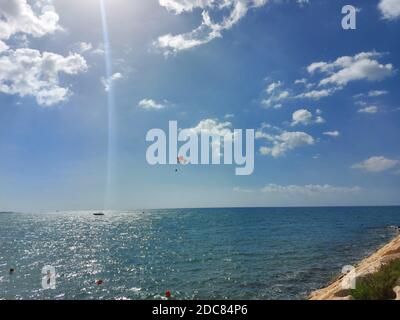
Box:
0, 0, 400, 211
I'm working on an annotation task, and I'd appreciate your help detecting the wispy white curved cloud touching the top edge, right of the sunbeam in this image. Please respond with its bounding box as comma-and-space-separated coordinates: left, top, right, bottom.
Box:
154, 0, 267, 55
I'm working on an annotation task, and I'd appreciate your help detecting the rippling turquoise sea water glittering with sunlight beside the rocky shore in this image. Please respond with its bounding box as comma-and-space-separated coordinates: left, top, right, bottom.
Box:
0, 207, 400, 299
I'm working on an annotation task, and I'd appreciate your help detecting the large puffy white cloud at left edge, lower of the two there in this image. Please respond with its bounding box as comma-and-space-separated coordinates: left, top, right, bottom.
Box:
0, 48, 87, 106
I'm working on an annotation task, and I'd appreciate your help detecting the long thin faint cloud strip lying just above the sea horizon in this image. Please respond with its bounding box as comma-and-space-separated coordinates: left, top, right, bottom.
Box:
262, 184, 361, 196
